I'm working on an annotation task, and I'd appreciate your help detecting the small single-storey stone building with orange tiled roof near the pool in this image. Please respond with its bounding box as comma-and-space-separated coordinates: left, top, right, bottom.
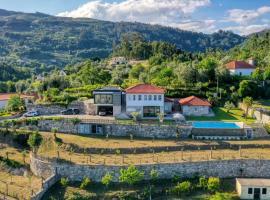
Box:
179, 96, 211, 116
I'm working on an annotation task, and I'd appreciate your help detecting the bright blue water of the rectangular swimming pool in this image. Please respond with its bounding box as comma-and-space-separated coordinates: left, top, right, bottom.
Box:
192, 122, 241, 129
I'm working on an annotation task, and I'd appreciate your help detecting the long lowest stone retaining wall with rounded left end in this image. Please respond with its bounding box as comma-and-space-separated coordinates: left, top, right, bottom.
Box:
30, 155, 270, 182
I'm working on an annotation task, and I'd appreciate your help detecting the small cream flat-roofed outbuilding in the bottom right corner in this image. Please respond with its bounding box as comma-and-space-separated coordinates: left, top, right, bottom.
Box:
236, 178, 270, 200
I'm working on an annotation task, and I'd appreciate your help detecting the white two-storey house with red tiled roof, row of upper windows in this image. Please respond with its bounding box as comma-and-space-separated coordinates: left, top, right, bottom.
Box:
126, 84, 165, 118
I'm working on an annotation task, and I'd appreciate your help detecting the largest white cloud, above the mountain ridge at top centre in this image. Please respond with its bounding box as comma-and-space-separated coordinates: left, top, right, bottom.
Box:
58, 0, 211, 26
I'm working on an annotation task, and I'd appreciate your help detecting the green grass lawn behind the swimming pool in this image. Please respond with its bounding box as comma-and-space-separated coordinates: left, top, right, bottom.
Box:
187, 107, 255, 124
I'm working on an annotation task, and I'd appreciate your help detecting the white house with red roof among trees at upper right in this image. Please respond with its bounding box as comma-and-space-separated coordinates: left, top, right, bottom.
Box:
225, 59, 256, 76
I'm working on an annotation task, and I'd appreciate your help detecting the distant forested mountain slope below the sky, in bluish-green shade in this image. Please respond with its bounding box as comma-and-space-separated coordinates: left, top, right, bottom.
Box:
0, 10, 245, 71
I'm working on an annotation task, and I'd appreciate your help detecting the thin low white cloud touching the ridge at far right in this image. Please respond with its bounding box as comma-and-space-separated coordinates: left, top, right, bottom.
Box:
224, 24, 270, 35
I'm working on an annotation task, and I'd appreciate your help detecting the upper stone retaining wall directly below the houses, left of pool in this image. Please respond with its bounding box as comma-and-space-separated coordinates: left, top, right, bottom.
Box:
38, 120, 192, 138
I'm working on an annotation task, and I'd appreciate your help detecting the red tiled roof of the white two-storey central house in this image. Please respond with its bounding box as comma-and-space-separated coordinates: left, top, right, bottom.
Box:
126, 84, 165, 94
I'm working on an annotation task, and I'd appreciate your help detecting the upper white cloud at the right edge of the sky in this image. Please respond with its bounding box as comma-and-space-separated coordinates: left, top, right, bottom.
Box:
226, 6, 270, 24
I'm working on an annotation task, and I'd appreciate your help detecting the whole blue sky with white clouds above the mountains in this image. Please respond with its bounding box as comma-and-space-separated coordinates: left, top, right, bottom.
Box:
0, 0, 270, 35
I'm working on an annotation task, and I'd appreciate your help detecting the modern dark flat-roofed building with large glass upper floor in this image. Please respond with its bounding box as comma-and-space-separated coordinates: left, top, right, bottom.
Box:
93, 86, 124, 116
